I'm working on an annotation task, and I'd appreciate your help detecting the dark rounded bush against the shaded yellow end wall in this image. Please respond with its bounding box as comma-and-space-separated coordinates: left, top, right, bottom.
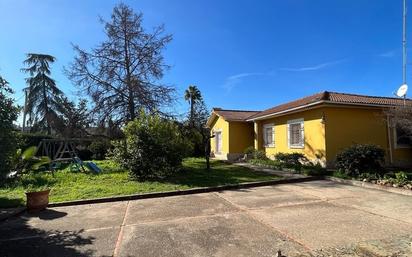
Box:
336, 144, 385, 177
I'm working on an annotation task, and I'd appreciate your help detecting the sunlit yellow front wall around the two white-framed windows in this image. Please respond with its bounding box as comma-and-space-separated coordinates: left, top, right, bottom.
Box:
255, 108, 326, 164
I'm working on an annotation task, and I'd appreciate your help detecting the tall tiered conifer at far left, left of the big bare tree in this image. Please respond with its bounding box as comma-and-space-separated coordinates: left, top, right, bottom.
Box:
22, 53, 63, 135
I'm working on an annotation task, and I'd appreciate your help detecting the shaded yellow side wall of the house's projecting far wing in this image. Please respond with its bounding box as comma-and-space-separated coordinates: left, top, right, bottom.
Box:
229, 121, 254, 155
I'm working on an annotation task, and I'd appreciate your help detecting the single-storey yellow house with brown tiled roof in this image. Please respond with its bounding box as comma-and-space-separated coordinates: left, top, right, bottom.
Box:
208, 91, 412, 166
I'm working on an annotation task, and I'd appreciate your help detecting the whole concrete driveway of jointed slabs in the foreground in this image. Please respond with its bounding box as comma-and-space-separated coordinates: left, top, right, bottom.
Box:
0, 181, 412, 257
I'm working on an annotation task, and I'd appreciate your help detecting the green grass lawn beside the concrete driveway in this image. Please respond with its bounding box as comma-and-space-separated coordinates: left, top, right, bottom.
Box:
0, 158, 278, 208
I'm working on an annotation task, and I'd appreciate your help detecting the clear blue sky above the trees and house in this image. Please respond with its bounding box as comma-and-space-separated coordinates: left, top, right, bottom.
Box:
0, 0, 412, 112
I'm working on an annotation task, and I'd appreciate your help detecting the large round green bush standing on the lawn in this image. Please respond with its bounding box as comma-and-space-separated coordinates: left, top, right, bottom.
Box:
112, 112, 191, 180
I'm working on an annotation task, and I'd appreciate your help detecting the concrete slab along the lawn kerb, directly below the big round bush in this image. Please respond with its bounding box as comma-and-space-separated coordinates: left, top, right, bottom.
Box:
126, 193, 238, 224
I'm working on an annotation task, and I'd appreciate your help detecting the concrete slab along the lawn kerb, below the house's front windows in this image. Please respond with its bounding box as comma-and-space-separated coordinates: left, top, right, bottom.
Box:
217, 186, 321, 208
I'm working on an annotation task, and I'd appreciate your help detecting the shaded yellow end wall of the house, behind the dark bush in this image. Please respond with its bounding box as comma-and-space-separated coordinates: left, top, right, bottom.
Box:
324, 106, 412, 166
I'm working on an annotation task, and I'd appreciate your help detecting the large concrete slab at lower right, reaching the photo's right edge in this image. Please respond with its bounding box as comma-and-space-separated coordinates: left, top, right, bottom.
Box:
251, 202, 412, 249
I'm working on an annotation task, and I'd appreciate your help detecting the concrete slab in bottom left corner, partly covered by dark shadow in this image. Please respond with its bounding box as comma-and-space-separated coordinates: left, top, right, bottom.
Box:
0, 228, 119, 257
